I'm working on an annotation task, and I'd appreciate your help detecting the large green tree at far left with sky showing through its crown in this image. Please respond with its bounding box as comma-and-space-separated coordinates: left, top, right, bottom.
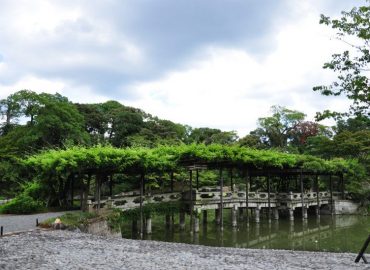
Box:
0, 90, 89, 156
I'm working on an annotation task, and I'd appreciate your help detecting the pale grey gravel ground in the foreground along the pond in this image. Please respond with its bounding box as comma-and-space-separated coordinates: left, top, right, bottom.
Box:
0, 230, 370, 270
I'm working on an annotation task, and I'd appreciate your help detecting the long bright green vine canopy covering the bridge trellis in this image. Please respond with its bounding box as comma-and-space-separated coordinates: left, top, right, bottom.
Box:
24, 144, 363, 176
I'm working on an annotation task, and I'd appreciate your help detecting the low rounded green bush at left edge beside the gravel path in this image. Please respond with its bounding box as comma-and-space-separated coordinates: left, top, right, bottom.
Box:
0, 193, 46, 214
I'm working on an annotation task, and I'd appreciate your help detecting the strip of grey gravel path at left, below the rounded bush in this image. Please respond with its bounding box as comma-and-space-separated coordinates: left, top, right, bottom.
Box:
0, 212, 71, 233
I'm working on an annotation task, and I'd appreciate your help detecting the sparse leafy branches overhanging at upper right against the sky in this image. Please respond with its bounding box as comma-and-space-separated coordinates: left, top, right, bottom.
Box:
314, 2, 370, 119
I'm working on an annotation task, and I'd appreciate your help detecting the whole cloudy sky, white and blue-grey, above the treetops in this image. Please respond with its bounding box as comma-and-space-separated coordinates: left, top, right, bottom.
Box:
0, 0, 366, 136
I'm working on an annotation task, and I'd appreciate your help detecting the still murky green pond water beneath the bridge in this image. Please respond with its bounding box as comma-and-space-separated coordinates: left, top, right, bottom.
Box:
121, 211, 370, 253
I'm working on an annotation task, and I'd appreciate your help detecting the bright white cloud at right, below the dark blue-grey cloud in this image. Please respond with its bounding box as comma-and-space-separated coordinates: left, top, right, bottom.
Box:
122, 2, 348, 136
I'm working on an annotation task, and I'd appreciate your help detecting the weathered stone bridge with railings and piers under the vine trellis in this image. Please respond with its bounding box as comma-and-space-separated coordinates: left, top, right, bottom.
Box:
89, 187, 342, 232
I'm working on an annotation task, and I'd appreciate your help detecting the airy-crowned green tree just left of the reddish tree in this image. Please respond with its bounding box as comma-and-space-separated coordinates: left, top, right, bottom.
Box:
251, 106, 306, 148
